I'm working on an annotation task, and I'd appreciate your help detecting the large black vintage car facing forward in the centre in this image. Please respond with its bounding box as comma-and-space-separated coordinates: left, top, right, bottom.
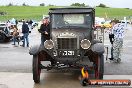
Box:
29, 8, 104, 83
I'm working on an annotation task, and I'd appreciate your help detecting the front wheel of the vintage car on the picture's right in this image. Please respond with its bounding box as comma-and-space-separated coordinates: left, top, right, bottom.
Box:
95, 54, 104, 79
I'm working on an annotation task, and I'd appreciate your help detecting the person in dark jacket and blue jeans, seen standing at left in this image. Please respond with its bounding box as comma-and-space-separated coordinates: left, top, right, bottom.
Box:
22, 21, 29, 47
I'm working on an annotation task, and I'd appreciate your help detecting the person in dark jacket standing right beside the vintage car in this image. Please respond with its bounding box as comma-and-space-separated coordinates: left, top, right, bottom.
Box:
39, 17, 50, 45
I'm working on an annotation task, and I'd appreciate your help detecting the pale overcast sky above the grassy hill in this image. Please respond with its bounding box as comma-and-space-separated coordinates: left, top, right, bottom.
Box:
0, 0, 132, 8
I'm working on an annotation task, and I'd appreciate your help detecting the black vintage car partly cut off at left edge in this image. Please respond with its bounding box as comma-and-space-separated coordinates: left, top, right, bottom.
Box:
0, 23, 12, 42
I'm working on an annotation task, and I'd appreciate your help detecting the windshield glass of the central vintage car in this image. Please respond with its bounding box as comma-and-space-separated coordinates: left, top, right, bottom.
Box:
52, 14, 92, 29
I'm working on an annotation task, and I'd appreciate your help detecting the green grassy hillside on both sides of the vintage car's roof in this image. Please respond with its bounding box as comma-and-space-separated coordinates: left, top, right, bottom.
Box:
0, 6, 132, 21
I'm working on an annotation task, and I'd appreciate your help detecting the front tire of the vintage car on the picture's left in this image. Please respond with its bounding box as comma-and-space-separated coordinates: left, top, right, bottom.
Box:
32, 55, 41, 83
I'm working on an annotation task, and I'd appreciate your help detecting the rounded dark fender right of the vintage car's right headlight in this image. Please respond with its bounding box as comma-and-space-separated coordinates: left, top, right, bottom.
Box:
91, 43, 105, 54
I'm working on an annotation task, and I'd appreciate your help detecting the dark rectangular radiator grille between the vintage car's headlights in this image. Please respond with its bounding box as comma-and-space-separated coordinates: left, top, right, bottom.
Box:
57, 38, 77, 49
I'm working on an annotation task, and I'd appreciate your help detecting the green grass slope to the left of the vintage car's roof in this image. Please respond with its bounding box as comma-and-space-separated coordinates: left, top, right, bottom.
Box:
0, 6, 55, 20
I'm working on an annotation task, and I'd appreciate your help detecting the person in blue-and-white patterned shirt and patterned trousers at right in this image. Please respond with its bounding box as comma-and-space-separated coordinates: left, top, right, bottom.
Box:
111, 20, 124, 62
